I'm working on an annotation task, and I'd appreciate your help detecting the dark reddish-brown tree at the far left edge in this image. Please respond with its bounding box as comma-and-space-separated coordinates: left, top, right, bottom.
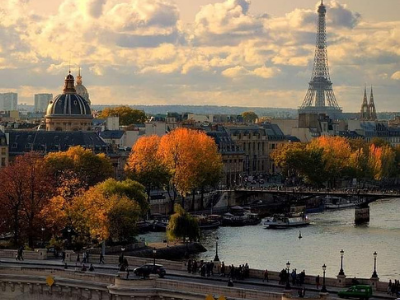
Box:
0, 152, 53, 247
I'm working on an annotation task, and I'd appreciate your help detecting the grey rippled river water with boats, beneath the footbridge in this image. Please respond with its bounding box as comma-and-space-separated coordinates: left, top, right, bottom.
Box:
138, 199, 400, 280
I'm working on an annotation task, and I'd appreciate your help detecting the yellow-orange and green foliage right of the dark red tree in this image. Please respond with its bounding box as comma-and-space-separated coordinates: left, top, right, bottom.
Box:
45, 179, 148, 243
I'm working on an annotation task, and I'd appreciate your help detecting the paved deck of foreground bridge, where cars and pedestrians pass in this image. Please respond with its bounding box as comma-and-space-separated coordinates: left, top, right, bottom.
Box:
0, 258, 395, 299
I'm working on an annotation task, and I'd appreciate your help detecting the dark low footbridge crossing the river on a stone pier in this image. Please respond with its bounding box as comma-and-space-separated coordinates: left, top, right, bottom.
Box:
214, 186, 400, 224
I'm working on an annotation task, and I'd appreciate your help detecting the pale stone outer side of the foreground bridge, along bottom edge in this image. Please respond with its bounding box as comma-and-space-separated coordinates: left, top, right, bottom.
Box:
0, 268, 283, 300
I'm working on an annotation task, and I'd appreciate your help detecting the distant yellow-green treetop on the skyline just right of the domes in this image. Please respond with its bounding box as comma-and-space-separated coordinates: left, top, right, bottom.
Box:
99, 105, 146, 126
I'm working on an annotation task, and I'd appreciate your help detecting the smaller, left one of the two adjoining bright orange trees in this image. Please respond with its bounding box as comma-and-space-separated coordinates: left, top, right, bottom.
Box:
125, 135, 169, 199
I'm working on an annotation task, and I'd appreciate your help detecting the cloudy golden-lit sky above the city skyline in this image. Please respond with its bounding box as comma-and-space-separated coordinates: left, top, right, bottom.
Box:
0, 0, 400, 112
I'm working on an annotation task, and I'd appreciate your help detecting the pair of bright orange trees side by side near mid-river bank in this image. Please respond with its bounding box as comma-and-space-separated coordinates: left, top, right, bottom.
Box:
126, 128, 222, 210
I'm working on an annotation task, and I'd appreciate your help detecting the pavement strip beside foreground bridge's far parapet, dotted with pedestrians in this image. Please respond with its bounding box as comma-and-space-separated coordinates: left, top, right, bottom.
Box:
0, 258, 396, 299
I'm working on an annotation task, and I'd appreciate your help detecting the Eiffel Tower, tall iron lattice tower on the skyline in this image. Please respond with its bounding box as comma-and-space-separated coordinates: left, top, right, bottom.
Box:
298, 0, 342, 119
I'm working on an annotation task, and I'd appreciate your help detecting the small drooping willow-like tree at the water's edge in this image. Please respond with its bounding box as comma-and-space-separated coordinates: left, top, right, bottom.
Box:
167, 204, 200, 241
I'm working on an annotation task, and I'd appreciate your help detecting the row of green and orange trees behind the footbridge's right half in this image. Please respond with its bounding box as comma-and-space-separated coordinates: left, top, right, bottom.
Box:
271, 136, 400, 187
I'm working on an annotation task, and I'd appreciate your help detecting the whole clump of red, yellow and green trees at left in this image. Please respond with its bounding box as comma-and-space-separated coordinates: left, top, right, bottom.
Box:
0, 147, 148, 247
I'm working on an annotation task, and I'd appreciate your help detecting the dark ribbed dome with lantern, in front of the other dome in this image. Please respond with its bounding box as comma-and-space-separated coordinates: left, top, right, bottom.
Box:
45, 72, 93, 131
